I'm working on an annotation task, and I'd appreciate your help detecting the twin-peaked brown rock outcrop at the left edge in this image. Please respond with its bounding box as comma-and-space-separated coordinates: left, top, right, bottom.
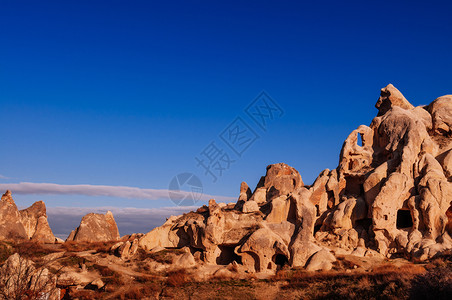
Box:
0, 191, 56, 243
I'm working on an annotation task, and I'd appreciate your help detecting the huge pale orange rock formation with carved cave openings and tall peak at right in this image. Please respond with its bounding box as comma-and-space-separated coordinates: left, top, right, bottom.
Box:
138, 85, 452, 272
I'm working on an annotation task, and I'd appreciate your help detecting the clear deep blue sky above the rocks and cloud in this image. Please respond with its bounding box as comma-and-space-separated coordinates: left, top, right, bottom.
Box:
0, 1, 452, 237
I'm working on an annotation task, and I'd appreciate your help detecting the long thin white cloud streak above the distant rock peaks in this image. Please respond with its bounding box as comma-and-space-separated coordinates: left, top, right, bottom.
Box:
0, 182, 236, 202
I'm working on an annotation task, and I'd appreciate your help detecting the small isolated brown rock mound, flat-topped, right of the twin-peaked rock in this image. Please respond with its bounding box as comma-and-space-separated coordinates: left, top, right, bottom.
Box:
66, 211, 120, 242
